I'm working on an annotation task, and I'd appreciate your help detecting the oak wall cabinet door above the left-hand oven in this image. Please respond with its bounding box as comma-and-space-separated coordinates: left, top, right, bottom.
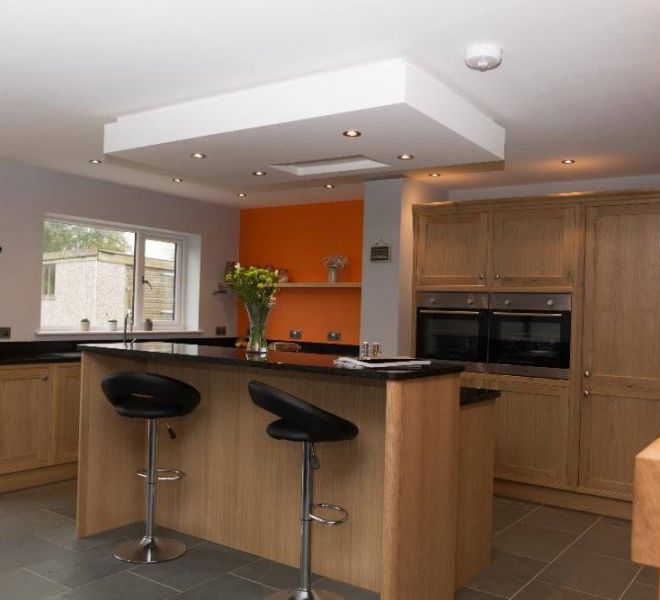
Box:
416, 212, 488, 288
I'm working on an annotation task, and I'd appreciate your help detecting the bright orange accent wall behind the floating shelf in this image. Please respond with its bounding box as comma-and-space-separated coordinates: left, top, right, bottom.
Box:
238, 200, 364, 344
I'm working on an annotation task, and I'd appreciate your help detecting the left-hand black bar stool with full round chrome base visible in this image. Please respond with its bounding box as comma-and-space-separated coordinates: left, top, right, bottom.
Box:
101, 372, 201, 564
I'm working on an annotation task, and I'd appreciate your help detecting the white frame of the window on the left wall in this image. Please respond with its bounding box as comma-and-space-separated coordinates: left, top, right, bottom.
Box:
40, 214, 187, 333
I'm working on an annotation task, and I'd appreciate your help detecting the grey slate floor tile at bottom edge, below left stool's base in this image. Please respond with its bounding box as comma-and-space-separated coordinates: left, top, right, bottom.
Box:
57, 572, 178, 600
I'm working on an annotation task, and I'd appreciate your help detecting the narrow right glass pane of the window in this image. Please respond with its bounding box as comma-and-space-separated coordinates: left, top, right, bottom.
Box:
142, 239, 177, 321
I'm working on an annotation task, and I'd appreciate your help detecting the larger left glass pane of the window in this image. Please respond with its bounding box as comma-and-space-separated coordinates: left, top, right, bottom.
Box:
41, 221, 135, 329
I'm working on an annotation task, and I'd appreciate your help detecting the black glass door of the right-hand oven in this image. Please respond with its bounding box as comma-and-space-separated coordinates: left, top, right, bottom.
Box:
488, 311, 571, 369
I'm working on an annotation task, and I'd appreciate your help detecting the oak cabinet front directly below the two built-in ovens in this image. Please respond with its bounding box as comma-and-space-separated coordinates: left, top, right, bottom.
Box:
461, 373, 577, 487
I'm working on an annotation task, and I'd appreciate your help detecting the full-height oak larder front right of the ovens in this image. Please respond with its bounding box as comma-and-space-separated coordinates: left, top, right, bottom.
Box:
580, 204, 660, 494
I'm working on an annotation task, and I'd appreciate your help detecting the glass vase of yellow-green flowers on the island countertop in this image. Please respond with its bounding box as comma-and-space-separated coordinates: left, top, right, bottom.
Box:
225, 263, 278, 354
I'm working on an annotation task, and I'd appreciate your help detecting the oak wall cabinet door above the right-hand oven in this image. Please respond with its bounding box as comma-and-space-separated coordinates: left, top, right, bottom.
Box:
489, 207, 577, 287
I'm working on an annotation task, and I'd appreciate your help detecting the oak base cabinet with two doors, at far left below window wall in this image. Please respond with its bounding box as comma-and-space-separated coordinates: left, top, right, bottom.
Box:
0, 363, 80, 482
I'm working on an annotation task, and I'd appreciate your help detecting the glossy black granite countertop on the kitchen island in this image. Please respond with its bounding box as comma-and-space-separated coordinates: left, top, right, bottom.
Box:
78, 342, 463, 380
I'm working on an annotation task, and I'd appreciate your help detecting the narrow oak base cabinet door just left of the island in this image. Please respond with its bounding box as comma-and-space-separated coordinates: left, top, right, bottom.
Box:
53, 364, 80, 464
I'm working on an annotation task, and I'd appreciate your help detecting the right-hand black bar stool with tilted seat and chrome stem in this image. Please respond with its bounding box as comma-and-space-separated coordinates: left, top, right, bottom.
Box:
248, 381, 359, 600
